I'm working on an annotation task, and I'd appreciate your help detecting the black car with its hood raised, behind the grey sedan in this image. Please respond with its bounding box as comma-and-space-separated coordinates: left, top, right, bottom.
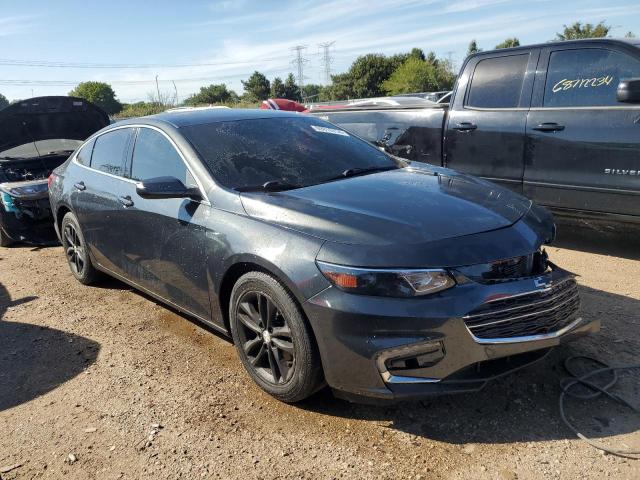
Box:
0, 97, 109, 247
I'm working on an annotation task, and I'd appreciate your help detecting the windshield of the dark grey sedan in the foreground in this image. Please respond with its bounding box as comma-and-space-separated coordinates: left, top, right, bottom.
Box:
181, 116, 401, 190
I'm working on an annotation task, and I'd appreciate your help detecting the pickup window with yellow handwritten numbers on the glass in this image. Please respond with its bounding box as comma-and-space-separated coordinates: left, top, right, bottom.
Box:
543, 48, 640, 107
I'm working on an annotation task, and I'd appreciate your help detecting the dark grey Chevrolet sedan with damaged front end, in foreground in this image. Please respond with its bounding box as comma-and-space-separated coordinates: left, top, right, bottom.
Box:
50, 110, 598, 402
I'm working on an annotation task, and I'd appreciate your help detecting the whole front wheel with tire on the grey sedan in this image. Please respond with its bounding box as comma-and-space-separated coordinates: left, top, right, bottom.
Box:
229, 272, 323, 403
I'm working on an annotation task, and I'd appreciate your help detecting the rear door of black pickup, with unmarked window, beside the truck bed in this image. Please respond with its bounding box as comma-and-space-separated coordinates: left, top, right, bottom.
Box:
444, 49, 539, 193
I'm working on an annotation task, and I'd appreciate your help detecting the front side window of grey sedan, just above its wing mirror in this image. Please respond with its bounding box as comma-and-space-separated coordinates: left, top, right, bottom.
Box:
131, 128, 195, 187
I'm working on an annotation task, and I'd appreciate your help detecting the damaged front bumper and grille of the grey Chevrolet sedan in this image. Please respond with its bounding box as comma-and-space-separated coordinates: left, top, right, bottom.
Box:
305, 267, 599, 400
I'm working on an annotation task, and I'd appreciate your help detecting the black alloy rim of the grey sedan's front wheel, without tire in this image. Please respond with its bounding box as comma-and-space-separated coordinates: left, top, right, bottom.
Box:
236, 292, 295, 385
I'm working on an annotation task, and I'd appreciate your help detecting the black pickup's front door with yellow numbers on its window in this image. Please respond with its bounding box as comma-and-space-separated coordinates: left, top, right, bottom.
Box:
524, 43, 640, 215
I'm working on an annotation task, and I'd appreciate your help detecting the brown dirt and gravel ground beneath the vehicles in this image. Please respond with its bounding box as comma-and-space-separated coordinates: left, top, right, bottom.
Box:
0, 229, 640, 480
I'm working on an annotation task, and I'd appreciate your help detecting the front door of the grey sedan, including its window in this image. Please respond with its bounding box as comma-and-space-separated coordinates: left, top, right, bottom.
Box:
116, 127, 211, 319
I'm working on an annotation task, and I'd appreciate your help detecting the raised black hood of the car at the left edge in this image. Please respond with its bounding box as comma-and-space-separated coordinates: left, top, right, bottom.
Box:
0, 97, 109, 156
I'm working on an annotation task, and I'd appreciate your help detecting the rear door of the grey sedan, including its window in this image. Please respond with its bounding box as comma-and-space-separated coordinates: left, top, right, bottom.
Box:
71, 128, 133, 275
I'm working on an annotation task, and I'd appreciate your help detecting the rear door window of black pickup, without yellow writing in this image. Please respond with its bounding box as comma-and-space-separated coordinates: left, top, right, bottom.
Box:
466, 53, 529, 108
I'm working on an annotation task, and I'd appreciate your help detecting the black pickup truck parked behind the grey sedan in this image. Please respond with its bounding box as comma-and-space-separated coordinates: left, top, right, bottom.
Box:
311, 39, 640, 227
